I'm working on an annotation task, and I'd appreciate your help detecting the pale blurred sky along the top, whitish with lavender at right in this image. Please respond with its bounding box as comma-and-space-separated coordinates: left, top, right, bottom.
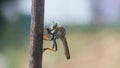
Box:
3, 0, 120, 24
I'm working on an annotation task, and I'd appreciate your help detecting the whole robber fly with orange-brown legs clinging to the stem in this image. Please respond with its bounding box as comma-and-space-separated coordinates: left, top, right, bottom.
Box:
43, 23, 70, 59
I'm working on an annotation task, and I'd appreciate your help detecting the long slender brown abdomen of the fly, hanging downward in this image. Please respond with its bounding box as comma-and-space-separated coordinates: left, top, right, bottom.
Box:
61, 36, 70, 59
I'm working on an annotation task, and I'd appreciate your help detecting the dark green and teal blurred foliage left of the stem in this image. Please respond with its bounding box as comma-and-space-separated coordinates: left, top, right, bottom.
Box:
0, 0, 30, 50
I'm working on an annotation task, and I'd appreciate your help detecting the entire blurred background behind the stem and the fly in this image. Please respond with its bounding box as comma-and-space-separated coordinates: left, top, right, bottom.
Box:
0, 0, 120, 68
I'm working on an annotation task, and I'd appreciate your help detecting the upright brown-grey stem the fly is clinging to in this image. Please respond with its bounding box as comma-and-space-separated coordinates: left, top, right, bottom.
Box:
29, 0, 44, 68
